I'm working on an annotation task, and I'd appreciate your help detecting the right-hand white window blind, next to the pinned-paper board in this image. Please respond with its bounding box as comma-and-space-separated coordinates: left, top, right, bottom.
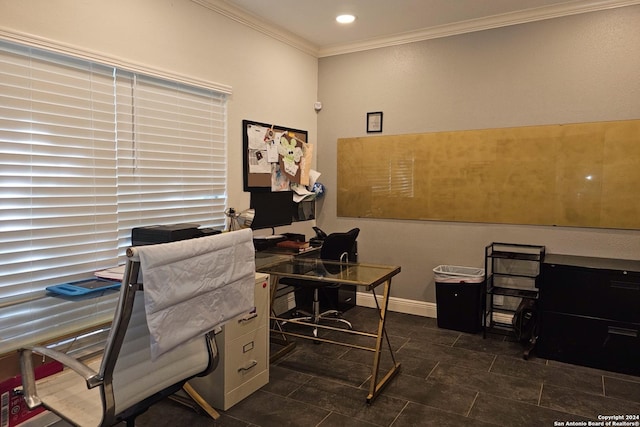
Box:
116, 72, 226, 251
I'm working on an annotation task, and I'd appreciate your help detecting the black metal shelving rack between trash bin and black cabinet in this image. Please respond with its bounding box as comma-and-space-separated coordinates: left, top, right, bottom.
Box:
483, 242, 545, 359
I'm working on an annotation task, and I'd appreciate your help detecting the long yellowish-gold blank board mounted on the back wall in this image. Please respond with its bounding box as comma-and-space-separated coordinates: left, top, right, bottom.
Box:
337, 120, 640, 229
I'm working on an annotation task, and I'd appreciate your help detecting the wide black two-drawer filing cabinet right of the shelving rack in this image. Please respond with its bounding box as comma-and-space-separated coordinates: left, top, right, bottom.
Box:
537, 254, 640, 375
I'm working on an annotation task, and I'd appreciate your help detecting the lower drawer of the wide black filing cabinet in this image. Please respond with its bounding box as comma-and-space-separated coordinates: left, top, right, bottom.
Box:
537, 312, 640, 375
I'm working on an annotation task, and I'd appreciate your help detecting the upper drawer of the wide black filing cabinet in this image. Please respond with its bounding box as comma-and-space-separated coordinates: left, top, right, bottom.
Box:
540, 264, 640, 323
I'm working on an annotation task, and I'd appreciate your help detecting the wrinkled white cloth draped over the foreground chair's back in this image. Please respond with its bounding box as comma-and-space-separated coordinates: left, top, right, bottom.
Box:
136, 229, 255, 360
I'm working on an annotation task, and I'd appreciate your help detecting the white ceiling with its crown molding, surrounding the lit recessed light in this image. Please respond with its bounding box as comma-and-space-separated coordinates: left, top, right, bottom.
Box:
198, 0, 640, 57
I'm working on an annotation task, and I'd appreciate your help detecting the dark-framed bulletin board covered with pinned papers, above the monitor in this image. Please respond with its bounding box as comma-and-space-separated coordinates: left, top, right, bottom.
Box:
242, 120, 313, 192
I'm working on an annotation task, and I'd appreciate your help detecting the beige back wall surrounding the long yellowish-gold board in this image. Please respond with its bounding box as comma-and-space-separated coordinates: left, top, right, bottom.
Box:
318, 6, 640, 302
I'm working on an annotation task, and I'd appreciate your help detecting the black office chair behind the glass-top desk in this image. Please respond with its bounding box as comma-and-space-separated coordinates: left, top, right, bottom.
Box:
280, 228, 360, 337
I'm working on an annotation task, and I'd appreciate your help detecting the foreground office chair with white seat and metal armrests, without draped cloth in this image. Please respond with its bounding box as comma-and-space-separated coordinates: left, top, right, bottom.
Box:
20, 247, 218, 427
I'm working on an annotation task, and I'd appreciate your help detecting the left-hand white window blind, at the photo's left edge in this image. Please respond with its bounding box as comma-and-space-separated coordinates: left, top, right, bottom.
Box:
0, 43, 117, 298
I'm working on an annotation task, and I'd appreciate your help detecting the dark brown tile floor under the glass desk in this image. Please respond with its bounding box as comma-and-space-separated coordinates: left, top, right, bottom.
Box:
137, 307, 640, 427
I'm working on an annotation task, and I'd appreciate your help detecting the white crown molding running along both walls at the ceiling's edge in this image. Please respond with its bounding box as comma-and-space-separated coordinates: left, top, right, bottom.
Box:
191, 0, 640, 58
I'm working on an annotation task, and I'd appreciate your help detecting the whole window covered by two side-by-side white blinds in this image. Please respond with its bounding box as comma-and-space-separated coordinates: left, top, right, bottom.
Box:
0, 41, 226, 306
